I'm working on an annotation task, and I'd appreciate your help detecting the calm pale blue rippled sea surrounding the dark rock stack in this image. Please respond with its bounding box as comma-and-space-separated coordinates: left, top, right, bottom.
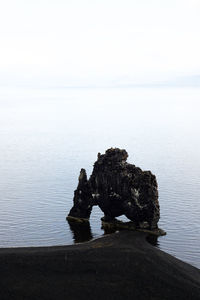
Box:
0, 88, 200, 268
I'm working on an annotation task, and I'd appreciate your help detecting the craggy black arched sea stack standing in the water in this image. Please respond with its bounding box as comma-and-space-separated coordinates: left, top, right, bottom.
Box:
68, 148, 160, 229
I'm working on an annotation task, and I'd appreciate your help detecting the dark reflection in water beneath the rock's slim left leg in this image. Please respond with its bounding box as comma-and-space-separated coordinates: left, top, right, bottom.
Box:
67, 220, 93, 243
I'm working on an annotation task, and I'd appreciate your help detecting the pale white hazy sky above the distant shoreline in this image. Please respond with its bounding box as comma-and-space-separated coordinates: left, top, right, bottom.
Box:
0, 0, 200, 86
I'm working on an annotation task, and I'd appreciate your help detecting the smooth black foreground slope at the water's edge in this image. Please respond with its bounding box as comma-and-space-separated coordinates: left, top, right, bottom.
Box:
0, 231, 200, 300
